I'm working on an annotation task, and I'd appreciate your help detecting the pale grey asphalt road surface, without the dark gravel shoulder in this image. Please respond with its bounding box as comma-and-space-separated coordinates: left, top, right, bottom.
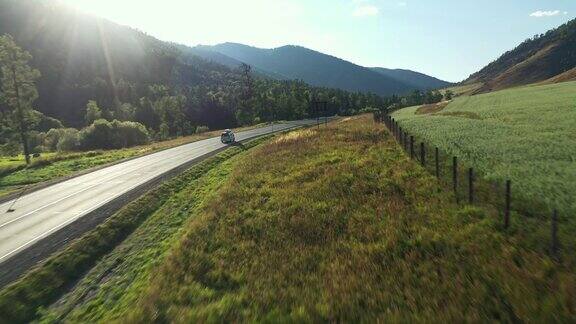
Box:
0, 120, 316, 263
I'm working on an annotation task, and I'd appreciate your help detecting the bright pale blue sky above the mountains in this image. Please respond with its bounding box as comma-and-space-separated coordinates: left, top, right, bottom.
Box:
64, 0, 576, 82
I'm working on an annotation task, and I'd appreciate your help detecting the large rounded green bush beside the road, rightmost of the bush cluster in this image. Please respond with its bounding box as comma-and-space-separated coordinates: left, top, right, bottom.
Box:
80, 119, 150, 150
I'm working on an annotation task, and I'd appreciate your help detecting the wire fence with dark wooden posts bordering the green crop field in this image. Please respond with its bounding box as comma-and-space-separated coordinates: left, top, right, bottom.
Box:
375, 115, 572, 260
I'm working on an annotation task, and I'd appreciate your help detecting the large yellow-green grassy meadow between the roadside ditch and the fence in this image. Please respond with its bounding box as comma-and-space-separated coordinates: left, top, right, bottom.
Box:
33, 116, 576, 322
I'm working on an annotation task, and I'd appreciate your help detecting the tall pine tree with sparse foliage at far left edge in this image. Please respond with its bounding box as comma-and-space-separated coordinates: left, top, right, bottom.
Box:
0, 35, 40, 164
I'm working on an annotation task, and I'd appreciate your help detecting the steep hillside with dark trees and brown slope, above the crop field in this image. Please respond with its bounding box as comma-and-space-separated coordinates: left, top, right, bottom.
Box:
464, 20, 576, 93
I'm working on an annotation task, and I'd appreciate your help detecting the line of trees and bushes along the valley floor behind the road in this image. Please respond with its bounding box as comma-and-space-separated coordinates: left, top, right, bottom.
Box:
0, 35, 391, 162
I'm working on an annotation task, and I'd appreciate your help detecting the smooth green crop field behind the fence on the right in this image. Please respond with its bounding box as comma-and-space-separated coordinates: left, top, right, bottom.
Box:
392, 82, 576, 217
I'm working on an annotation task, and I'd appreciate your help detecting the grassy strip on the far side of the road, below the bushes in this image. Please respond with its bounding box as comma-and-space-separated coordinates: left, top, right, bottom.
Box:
0, 124, 274, 197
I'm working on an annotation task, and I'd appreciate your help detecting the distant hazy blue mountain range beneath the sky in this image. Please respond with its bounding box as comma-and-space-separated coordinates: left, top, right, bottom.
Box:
189, 43, 450, 96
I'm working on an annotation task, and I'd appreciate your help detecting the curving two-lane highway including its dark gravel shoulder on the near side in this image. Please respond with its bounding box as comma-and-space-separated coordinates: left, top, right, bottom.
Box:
0, 120, 316, 286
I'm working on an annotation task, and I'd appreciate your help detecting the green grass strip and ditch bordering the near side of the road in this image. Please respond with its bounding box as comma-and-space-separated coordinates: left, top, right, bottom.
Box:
0, 138, 272, 323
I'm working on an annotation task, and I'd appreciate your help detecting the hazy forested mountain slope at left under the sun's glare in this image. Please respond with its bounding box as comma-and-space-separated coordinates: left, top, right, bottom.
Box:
0, 0, 243, 126
